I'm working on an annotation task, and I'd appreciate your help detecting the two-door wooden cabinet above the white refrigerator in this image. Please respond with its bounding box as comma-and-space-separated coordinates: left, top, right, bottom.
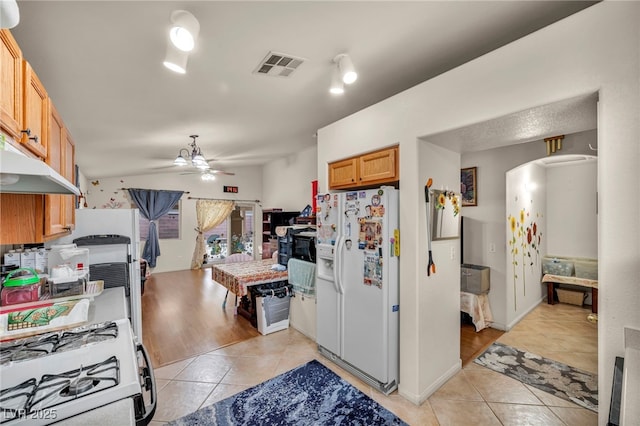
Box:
329, 146, 400, 189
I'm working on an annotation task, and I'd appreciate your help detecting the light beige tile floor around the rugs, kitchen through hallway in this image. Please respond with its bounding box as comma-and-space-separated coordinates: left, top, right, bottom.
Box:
151, 303, 598, 426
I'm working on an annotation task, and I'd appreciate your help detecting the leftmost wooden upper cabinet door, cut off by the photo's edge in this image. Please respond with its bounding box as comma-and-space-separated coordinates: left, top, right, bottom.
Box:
0, 30, 22, 140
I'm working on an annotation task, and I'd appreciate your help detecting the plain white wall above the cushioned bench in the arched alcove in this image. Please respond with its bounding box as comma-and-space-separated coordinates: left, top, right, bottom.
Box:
546, 160, 596, 259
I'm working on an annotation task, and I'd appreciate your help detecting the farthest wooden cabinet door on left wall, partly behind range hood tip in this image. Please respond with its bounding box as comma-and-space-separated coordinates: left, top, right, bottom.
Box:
44, 104, 66, 238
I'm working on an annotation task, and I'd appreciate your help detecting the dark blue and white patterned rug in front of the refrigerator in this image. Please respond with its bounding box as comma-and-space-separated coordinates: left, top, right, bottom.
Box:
168, 360, 406, 426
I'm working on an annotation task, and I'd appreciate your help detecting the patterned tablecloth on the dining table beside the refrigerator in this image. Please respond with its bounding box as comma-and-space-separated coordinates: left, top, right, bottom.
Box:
211, 259, 288, 296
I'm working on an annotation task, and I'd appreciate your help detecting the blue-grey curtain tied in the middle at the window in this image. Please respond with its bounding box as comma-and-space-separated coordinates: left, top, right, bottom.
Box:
129, 188, 184, 268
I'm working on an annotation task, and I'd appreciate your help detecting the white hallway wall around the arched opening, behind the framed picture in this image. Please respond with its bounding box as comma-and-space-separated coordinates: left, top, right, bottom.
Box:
461, 130, 598, 330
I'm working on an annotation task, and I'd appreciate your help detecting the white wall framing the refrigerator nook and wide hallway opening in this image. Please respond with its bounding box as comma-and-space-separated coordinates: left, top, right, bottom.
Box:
318, 2, 640, 424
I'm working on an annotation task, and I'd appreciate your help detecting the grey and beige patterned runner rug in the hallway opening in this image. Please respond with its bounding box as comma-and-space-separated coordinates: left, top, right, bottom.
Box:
475, 343, 598, 413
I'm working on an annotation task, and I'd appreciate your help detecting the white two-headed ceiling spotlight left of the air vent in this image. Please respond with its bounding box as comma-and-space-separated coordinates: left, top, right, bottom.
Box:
163, 10, 200, 74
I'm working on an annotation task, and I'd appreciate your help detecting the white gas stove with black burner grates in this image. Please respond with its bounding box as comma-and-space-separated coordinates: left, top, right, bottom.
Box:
0, 319, 156, 426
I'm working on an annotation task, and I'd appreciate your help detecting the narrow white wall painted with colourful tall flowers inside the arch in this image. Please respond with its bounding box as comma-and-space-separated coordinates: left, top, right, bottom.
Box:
505, 163, 548, 329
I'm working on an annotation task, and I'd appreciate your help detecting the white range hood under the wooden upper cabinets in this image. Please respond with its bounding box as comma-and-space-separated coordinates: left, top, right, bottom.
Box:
0, 151, 80, 195
